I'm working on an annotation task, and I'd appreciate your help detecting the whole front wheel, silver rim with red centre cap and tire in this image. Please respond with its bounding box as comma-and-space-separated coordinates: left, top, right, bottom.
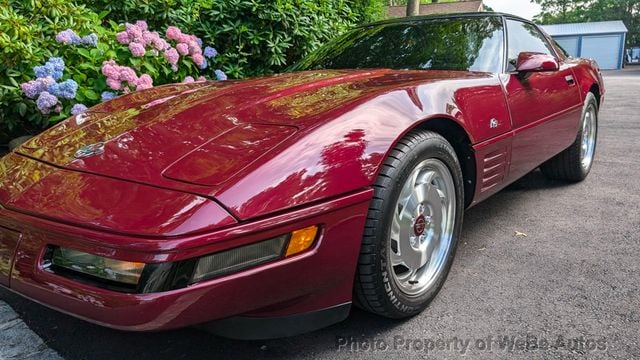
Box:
354, 132, 464, 318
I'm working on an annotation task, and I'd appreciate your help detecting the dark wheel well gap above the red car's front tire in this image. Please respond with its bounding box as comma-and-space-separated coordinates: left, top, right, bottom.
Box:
416, 119, 476, 207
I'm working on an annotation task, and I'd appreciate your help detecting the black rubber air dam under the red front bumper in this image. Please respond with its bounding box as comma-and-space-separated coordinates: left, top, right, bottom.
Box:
198, 302, 351, 340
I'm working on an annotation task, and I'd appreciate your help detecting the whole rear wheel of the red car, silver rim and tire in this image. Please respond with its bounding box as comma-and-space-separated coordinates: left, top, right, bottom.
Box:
540, 93, 598, 181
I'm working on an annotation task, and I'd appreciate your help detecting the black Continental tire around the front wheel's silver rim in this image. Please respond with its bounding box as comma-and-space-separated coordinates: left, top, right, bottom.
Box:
354, 131, 464, 319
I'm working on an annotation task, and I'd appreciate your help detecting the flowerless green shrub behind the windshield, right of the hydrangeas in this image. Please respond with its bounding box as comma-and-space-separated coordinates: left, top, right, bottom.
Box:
79, 0, 384, 78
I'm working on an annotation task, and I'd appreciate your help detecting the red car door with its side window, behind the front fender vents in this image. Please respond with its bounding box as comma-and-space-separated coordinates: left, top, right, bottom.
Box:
502, 18, 582, 180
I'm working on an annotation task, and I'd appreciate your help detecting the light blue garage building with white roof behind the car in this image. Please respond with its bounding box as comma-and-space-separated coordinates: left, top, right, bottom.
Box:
542, 21, 628, 69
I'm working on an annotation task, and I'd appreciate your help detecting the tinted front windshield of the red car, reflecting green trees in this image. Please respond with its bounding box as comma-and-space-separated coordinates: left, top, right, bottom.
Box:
293, 16, 504, 72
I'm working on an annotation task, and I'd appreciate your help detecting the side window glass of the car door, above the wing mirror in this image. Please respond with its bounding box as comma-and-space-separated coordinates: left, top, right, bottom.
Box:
507, 20, 554, 71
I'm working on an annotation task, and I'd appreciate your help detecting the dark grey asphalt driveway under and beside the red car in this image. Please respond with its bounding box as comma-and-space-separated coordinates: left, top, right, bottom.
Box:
0, 68, 640, 360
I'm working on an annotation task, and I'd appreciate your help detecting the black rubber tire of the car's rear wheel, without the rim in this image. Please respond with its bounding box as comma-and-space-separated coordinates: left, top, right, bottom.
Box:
540, 93, 598, 182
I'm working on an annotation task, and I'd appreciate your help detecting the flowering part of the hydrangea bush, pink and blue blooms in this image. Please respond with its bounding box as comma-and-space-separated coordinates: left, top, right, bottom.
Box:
20, 20, 227, 123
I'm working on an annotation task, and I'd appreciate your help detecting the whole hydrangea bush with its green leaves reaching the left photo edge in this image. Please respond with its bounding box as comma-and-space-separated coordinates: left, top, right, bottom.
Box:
0, 0, 226, 145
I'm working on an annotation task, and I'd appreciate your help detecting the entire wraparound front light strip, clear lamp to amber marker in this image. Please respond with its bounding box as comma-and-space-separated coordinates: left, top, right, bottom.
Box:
42, 225, 320, 294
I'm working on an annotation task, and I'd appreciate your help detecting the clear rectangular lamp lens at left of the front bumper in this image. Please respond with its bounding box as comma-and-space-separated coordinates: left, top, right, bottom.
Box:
51, 247, 145, 285
